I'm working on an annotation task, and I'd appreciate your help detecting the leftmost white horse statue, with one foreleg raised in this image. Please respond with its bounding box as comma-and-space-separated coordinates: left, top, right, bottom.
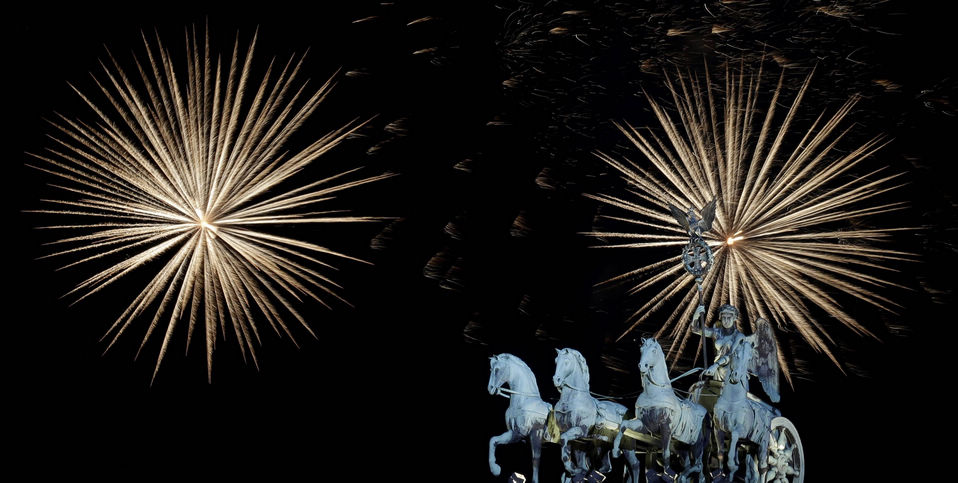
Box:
488, 354, 552, 483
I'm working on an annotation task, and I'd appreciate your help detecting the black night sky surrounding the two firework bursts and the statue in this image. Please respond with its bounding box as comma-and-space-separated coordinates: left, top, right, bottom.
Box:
9, 1, 958, 481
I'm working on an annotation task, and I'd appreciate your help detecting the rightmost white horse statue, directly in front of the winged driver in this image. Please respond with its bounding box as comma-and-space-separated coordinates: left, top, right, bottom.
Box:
712, 338, 776, 481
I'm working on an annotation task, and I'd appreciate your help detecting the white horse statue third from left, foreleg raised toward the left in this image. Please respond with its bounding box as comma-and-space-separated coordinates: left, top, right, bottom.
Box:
612, 339, 711, 482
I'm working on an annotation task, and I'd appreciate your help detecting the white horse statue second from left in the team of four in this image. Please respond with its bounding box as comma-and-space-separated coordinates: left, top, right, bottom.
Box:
552, 349, 639, 479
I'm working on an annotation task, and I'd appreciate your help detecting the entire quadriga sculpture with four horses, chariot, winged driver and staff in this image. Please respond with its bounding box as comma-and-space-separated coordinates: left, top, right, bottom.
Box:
488, 200, 805, 483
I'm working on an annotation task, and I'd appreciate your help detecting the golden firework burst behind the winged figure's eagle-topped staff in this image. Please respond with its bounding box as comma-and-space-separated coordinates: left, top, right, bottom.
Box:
588, 63, 910, 381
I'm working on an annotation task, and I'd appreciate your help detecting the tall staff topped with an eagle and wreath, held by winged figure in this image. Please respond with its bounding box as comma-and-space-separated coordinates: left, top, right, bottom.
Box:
669, 199, 716, 365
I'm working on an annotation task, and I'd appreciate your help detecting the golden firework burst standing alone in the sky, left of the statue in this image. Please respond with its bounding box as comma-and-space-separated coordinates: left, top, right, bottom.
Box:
31, 29, 389, 379
